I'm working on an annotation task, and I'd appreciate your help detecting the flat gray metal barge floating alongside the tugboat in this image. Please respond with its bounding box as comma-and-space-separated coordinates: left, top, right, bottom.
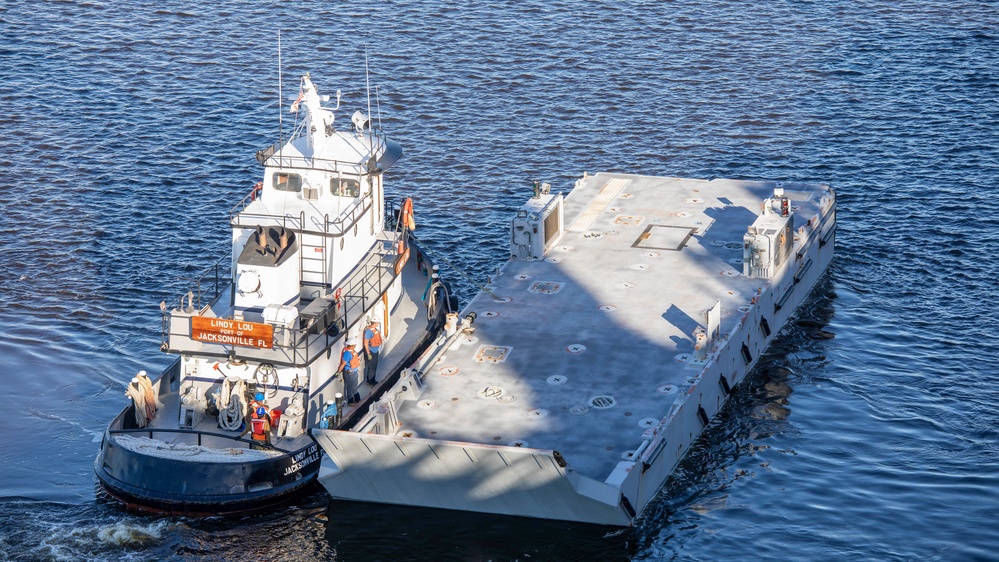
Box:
312, 173, 836, 526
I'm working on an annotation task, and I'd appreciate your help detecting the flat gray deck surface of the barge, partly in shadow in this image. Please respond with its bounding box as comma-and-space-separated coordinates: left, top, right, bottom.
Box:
399, 173, 820, 481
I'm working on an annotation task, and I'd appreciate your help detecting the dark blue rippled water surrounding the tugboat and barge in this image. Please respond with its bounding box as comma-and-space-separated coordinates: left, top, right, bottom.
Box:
0, 0, 999, 561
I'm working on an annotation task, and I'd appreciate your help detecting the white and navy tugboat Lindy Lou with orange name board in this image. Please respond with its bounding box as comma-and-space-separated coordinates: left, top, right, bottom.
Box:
94, 74, 456, 516
